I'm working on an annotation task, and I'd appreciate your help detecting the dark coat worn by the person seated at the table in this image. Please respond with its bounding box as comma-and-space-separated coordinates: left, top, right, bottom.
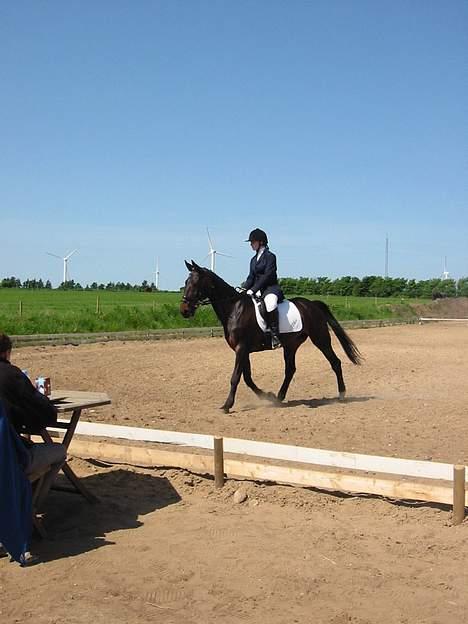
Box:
0, 358, 57, 433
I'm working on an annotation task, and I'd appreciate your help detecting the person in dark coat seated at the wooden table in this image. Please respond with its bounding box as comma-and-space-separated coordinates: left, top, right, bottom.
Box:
0, 333, 67, 475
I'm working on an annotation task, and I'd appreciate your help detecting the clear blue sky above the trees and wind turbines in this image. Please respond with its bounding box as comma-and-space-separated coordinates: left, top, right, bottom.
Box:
0, 0, 468, 288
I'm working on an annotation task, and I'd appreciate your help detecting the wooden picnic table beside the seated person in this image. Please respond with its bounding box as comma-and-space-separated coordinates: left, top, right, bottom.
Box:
40, 390, 111, 503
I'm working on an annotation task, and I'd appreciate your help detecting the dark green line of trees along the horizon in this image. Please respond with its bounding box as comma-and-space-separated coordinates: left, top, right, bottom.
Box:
0, 275, 468, 299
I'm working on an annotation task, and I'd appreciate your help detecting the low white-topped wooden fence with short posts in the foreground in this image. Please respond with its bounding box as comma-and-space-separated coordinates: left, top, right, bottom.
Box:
56, 422, 468, 524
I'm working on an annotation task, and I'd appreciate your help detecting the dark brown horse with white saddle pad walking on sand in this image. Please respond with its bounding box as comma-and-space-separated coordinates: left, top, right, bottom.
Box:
180, 260, 362, 414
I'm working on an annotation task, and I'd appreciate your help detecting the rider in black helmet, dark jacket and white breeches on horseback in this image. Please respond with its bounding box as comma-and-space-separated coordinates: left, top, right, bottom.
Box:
244, 228, 284, 349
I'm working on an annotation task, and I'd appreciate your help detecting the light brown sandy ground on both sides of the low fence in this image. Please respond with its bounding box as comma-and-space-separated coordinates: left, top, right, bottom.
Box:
0, 323, 468, 624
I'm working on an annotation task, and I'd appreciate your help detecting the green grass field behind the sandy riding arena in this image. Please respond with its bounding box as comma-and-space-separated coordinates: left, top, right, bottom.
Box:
0, 288, 422, 335
